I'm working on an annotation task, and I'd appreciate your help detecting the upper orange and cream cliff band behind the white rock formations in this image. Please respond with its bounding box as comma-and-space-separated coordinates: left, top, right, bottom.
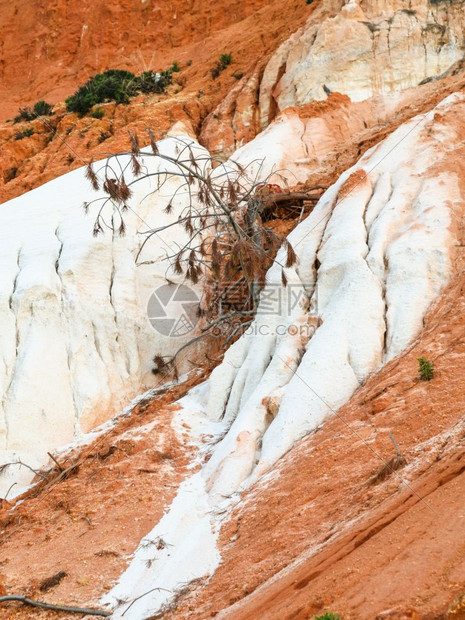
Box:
0, 0, 464, 200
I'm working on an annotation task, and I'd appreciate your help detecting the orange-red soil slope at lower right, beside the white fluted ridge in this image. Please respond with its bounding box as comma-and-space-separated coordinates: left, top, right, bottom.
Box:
159, 253, 465, 620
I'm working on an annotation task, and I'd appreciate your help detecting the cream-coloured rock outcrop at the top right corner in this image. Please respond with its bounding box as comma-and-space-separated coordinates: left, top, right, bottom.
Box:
259, 0, 465, 128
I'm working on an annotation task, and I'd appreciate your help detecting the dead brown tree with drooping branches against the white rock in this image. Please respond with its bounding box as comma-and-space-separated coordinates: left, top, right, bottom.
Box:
84, 129, 319, 372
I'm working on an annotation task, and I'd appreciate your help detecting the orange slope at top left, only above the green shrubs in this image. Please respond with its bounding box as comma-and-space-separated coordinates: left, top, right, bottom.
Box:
0, 0, 310, 119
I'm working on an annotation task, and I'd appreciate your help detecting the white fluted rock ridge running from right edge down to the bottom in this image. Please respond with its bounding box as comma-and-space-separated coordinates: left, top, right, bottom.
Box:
103, 95, 465, 620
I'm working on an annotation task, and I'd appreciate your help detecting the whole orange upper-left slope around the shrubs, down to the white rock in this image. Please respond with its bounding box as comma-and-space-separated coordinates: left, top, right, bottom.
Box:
0, 0, 314, 202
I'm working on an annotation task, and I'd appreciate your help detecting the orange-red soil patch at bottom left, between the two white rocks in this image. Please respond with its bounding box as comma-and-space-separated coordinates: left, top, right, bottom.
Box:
0, 375, 210, 620
